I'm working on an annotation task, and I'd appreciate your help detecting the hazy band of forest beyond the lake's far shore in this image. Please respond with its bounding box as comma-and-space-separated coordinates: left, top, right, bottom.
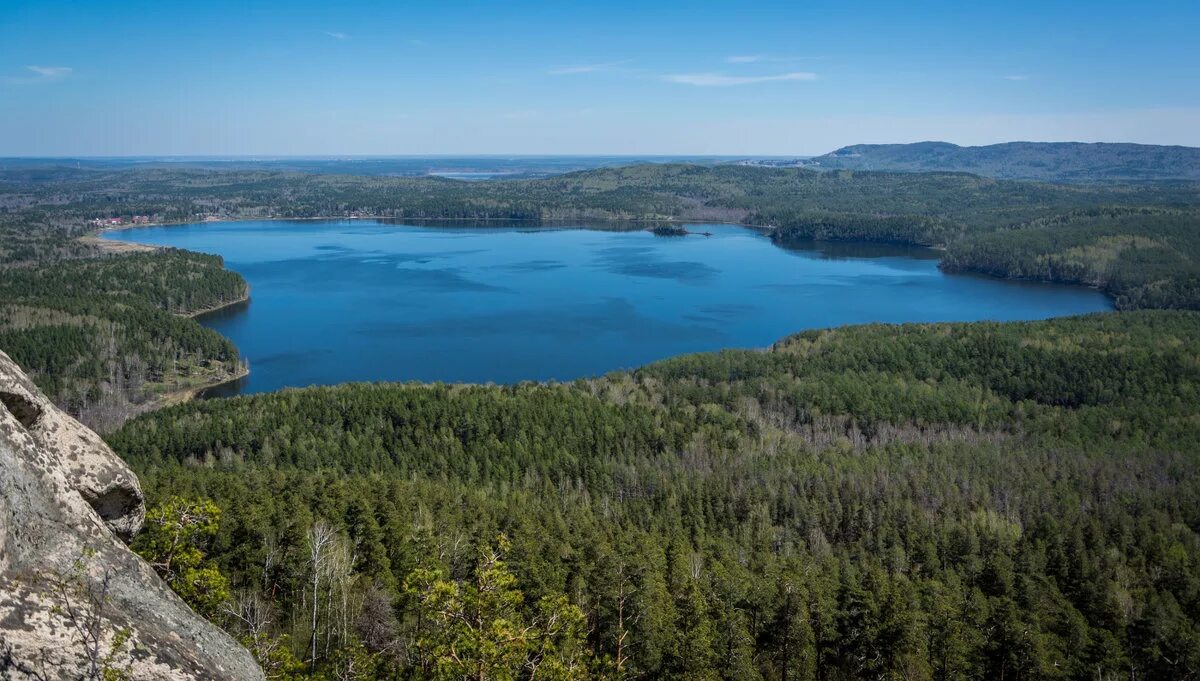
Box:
9, 164, 1200, 227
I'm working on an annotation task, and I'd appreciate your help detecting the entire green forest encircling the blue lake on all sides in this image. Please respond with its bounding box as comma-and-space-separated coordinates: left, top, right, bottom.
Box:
0, 164, 1200, 681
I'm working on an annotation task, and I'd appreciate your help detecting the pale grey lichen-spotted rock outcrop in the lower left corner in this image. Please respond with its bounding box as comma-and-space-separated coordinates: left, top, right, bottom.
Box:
0, 352, 263, 680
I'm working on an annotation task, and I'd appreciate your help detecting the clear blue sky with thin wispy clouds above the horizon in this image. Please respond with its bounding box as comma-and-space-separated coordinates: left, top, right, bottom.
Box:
0, 0, 1200, 156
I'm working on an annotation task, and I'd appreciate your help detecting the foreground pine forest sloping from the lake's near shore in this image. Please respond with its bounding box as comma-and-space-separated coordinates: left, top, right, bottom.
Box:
109, 312, 1200, 680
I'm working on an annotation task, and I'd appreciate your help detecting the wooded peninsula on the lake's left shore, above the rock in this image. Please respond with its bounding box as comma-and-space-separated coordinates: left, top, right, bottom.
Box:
0, 215, 247, 432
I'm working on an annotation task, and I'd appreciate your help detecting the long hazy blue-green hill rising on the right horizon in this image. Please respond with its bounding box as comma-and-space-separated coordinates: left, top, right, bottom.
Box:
809, 141, 1200, 182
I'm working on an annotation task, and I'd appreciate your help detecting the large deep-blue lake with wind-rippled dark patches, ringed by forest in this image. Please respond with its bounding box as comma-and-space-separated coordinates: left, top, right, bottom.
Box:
108, 221, 1111, 392
